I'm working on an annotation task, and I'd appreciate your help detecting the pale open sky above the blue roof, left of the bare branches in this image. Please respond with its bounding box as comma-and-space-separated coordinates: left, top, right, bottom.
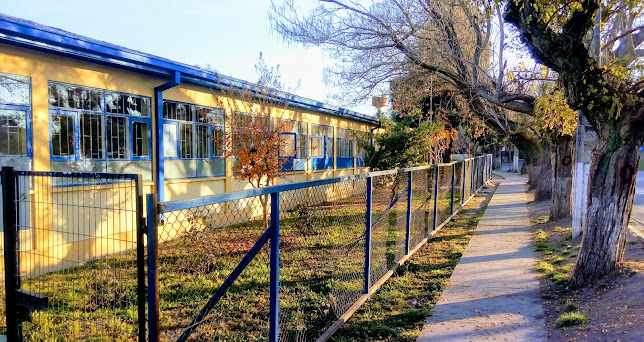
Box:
0, 0, 376, 115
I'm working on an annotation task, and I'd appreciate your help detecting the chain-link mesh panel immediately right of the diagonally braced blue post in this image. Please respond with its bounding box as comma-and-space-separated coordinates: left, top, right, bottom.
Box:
279, 179, 367, 341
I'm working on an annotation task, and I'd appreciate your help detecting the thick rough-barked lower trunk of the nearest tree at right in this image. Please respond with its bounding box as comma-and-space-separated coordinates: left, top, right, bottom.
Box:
571, 138, 640, 286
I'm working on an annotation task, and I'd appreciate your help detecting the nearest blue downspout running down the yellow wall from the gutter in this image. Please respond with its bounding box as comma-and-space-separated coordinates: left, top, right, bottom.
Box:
154, 71, 181, 202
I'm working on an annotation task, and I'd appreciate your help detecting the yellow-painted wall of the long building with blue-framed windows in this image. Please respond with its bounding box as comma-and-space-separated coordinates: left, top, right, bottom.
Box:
0, 44, 371, 274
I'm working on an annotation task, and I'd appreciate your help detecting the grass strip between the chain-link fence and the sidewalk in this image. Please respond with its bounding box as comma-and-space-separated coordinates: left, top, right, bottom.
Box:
332, 187, 493, 342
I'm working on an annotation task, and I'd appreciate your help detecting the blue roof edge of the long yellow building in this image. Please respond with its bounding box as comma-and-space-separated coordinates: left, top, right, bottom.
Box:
0, 13, 379, 124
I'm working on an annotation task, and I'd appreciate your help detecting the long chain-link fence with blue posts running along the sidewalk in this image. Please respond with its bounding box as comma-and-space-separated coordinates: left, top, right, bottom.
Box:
148, 156, 491, 341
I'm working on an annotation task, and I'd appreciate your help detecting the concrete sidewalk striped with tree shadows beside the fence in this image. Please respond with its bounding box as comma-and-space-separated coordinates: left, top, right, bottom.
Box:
418, 172, 547, 342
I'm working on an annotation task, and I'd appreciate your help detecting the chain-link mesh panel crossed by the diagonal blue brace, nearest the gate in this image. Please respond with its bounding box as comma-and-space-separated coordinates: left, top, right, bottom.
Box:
158, 195, 271, 341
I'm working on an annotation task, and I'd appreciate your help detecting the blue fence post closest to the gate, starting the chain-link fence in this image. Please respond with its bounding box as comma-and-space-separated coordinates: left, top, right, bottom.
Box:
147, 194, 159, 342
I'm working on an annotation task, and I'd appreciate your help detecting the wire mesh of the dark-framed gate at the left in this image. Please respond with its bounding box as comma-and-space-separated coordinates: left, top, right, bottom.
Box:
7, 171, 143, 341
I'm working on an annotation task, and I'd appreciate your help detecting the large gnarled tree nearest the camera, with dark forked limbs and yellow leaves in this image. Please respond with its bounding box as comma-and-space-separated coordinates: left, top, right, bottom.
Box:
505, 0, 644, 285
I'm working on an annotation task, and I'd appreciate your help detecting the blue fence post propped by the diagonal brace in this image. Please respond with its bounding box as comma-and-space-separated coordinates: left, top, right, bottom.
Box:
269, 192, 280, 342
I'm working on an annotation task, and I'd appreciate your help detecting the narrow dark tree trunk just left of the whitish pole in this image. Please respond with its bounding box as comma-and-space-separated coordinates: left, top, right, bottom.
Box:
550, 137, 575, 221
